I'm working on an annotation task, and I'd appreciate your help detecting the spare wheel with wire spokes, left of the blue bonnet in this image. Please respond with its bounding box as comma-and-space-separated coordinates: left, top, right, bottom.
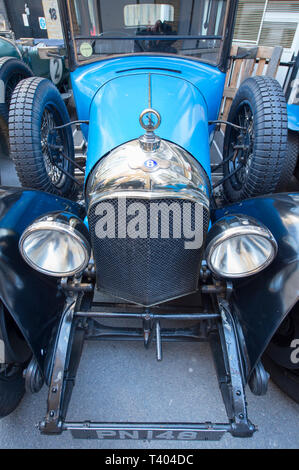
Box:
9, 78, 76, 197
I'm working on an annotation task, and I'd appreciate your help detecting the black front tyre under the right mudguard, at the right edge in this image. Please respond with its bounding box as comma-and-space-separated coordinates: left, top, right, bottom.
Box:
263, 304, 299, 403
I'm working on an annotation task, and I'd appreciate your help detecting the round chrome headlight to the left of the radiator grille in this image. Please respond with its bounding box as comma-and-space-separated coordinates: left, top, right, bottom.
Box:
19, 213, 91, 277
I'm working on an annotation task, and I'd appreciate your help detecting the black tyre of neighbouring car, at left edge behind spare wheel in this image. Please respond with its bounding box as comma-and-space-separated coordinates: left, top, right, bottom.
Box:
0, 57, 33, 155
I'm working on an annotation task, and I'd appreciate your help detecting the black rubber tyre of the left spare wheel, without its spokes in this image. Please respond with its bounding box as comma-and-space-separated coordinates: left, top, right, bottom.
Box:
9, 77, 76, 198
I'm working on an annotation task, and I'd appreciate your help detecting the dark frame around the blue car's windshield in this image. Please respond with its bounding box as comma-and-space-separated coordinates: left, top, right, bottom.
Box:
58, 0, 239, 72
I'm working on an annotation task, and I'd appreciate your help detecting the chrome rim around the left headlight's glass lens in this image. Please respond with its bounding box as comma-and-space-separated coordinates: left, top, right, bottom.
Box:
19, 215, 91, 278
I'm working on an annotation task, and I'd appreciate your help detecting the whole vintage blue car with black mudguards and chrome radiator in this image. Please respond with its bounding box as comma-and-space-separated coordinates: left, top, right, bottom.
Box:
0, 0, 299, 440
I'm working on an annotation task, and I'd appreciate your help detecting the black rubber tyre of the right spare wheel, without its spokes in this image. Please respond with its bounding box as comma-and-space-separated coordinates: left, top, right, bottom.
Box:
223, 77, 288, 202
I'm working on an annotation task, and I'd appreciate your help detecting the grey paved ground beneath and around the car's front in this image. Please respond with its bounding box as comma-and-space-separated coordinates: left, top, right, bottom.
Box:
0, 336, 299, 449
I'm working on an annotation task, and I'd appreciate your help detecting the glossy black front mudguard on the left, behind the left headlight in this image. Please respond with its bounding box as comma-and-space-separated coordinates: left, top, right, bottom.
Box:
0, 188, 84, 370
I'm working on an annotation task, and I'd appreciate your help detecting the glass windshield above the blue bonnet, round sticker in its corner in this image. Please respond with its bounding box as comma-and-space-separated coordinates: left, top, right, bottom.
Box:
68, 0, 228, 65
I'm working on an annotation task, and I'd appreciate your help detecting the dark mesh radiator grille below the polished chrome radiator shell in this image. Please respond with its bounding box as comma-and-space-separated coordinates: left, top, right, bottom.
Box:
89, 198, 209, 306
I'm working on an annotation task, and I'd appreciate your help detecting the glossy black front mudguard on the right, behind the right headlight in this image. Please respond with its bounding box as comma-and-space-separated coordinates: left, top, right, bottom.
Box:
213, 193, 299, 378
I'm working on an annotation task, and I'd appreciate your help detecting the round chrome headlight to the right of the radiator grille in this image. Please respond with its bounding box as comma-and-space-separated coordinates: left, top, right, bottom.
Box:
206, 215, 277, 278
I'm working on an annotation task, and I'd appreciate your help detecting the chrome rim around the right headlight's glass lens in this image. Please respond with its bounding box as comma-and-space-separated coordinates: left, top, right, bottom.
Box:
205, 215, 278, 279
